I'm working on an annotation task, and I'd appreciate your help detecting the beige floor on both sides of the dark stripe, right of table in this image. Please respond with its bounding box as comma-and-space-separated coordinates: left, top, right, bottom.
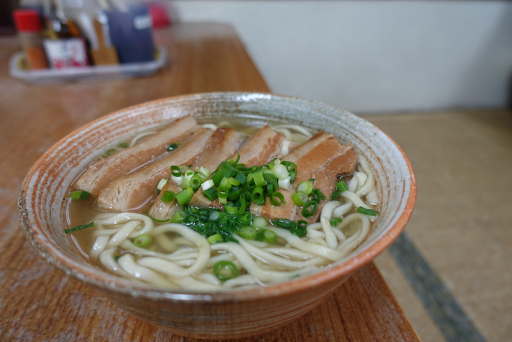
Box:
365, 110, 512, 342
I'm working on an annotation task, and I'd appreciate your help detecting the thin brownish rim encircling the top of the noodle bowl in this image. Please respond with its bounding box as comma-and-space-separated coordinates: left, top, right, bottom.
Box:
18, 92, 416, 304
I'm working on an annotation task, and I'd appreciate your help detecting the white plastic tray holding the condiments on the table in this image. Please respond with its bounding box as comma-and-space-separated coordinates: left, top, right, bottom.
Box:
9, 47, 167, 85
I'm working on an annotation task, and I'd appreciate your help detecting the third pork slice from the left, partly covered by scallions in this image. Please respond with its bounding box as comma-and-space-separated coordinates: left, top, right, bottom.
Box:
149, 128, 246, 220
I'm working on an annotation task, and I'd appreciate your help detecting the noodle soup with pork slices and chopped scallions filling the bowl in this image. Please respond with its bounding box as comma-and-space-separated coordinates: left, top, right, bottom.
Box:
66, 116, 379, 291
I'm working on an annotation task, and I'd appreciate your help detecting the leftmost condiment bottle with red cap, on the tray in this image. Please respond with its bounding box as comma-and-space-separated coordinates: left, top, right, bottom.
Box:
14, 9, 48, 69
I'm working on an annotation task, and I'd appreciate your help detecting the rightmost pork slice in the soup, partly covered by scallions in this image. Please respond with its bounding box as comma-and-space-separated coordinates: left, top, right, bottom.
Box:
251, 132, 358, 223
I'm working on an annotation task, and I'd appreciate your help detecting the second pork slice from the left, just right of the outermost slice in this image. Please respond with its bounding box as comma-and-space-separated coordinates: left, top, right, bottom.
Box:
97, 128, 213, 212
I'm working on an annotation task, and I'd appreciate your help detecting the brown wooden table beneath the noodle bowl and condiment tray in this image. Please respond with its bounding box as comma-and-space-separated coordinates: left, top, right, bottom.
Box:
0, 24, 419, 341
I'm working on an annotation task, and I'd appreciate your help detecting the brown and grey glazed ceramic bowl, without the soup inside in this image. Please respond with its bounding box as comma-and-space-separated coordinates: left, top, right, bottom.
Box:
19, 93, 416, 339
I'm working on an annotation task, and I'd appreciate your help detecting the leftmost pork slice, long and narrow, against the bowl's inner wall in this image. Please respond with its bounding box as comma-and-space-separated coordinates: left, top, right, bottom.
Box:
74, 116, 198, 196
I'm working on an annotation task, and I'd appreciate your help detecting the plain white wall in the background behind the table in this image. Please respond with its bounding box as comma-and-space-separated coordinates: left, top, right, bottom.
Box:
171, 1, 512, 112
